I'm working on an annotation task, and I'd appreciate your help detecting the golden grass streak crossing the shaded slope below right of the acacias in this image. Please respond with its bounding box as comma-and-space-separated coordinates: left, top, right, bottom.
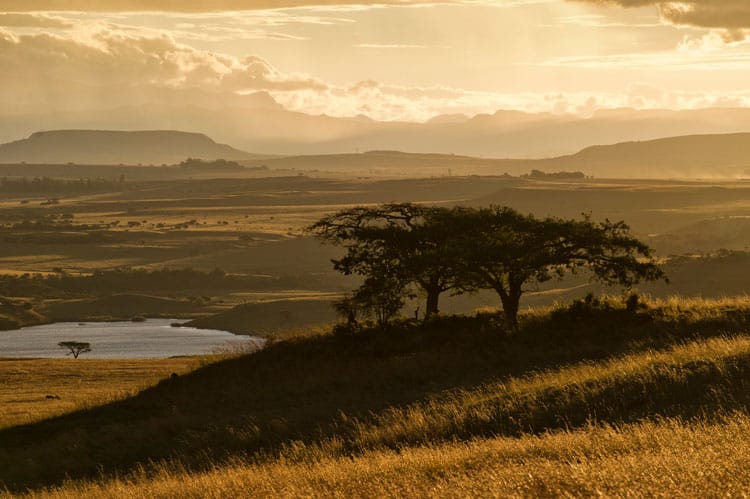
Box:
346, 337, 750, 448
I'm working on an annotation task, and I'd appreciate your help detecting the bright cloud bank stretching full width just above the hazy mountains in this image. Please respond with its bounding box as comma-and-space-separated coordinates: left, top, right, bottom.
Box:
0, 20, 750, 121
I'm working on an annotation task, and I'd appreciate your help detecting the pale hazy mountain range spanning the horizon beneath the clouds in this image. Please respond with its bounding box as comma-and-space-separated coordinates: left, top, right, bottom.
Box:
0, 88, 750, 159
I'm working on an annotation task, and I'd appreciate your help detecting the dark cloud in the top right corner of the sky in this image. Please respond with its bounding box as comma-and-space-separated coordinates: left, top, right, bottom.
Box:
569, 0, 750, 33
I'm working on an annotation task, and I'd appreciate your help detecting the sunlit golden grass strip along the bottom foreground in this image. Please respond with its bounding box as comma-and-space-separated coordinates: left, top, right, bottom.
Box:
20, 414, 750, 499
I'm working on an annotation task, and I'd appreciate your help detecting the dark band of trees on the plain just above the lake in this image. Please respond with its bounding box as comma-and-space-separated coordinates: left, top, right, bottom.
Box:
0, 268, 314, 297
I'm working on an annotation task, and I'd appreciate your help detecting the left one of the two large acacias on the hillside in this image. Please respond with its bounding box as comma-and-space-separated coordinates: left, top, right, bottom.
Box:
309, 203, 470, 317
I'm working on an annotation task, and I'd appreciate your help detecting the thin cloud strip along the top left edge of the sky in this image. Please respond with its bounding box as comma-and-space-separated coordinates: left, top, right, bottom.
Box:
0, 0, 451, 12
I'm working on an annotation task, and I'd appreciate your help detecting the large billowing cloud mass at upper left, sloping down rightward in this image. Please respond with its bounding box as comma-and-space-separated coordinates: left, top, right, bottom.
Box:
0, 22, 321, 92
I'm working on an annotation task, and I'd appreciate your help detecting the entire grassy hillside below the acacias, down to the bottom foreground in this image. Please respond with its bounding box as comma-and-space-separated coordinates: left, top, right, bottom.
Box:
0, 299, 750, 497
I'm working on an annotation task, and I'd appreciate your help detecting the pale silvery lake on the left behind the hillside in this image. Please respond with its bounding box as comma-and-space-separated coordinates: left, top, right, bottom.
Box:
0, 319, 264, 359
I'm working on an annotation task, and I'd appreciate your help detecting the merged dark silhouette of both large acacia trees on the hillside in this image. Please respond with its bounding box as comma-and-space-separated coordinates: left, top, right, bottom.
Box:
310, 203, 665, 328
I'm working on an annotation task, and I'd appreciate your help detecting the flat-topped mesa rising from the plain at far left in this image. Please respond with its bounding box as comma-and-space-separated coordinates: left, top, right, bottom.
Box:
0, 130, 257, 165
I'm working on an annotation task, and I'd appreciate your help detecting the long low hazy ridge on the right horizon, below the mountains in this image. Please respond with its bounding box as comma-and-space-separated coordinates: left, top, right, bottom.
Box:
244, 133, 750, 178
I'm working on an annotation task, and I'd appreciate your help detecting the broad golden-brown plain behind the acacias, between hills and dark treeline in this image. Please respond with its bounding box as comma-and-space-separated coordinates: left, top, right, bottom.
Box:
0, 172, 750, 282
